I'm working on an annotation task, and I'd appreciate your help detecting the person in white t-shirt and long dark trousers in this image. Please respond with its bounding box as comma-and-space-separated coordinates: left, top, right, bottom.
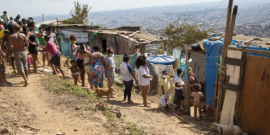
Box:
119, 54, 138, 103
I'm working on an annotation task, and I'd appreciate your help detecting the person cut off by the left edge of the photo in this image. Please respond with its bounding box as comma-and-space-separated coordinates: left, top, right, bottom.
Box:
0, 47, 11, 86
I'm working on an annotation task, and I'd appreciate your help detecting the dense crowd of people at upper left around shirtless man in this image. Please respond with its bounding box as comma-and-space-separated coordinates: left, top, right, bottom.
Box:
0, 11, 66, 86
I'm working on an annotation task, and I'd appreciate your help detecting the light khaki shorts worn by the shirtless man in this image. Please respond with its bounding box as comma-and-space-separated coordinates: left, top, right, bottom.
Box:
14, 51, 28, 71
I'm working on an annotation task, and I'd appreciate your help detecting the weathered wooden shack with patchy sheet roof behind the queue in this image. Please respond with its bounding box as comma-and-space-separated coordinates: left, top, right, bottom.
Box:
86, 26, 167, 55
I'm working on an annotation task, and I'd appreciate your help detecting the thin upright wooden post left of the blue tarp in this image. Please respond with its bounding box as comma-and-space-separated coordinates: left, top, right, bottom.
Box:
185, 45, 190, 115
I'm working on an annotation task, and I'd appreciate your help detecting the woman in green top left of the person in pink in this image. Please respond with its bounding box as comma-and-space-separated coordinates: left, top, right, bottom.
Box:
37, 27, 49, 67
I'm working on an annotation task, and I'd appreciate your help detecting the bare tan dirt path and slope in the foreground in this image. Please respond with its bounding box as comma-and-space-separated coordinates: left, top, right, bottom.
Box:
0, 61, 217, 135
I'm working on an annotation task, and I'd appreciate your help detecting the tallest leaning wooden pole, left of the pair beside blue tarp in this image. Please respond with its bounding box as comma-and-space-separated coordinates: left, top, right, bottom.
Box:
215, 0, 233, 123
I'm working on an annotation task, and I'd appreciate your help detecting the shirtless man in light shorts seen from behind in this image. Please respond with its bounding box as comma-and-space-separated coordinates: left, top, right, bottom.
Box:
8, 24, 29, 86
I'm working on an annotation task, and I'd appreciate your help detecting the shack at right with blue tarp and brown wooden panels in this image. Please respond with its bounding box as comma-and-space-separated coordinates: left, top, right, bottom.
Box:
196, 35, 270, 135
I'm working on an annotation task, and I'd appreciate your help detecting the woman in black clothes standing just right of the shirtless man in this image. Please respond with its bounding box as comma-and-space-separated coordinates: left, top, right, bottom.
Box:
26, 21, 38, 74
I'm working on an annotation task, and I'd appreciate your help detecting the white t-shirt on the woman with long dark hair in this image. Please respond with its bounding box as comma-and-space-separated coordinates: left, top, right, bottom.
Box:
138, 66, 150, 86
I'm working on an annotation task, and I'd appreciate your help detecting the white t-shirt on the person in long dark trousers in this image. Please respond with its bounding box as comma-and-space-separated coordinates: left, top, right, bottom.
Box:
119, 62, 133, 81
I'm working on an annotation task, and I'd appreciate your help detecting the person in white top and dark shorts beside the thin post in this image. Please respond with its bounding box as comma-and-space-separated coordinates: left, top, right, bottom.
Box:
174, 68, 185, 109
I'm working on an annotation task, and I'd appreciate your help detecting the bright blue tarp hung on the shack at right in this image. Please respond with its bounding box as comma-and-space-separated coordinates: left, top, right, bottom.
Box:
203, 41, 270, 106
